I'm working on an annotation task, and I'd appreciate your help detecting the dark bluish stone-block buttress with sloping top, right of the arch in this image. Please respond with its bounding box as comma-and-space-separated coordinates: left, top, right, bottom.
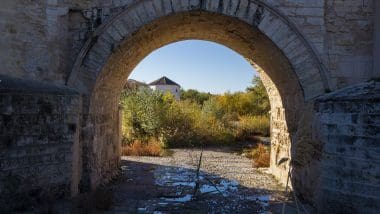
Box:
314, 82, 380, 213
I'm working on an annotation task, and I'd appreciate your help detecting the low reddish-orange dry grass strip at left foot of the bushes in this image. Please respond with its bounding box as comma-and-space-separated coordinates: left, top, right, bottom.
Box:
121, 140, 163, 156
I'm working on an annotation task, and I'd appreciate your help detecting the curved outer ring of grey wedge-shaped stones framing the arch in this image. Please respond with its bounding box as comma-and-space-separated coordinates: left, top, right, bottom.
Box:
66, 0, 330, 100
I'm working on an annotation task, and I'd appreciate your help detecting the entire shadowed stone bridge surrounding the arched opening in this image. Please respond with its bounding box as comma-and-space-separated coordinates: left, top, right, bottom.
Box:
0, 0, 380, 213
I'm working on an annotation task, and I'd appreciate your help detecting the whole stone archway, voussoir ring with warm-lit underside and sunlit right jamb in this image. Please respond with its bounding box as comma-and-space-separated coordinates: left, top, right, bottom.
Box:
67, 0, 328, 202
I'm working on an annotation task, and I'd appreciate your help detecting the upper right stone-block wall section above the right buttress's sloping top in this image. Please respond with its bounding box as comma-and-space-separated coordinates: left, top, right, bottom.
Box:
324, 0, 378, 88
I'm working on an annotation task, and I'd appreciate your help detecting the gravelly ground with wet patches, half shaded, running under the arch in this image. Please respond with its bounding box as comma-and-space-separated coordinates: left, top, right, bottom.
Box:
104, 149, 294, 214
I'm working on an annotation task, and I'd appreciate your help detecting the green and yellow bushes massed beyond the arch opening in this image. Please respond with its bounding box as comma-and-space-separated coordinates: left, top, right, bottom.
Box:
121, 77, 270, 156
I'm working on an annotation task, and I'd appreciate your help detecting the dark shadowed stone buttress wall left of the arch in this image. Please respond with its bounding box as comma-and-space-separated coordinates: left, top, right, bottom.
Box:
0, 76, 81, 211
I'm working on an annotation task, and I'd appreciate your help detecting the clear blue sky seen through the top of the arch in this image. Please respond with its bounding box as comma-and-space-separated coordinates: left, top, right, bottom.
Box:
129, 40, 257, 94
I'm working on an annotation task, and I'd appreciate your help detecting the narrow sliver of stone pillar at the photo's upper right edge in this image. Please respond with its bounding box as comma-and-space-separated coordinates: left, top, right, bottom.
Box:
373, 1, 380, 79
